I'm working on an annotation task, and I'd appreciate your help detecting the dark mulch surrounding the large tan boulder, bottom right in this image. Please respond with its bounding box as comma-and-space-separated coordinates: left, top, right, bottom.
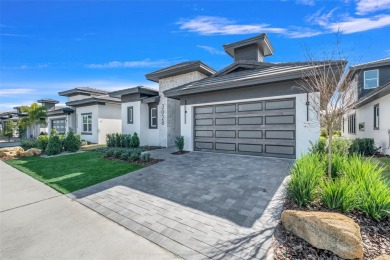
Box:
273, 198, 390, 259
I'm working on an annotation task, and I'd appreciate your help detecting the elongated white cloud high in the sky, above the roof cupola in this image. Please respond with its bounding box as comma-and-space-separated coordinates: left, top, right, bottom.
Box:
177, 16, 286, 35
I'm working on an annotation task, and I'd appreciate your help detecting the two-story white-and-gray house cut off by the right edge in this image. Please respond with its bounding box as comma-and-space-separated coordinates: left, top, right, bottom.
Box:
342, 58, 390, 154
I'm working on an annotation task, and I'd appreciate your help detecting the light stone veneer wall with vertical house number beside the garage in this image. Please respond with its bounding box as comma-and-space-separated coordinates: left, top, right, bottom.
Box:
158, 71, 207, 147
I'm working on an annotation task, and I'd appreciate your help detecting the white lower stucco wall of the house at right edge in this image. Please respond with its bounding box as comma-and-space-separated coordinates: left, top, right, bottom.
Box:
342, 95, 390, 154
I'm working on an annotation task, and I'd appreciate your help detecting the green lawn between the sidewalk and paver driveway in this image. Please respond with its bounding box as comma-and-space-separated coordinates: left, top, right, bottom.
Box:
5, 152, 142, 193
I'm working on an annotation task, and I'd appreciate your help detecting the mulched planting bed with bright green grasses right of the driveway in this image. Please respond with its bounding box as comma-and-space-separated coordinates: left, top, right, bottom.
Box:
273, 138, 390, 259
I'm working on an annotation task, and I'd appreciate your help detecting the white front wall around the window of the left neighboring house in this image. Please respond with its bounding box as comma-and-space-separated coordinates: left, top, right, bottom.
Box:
76, 105, 99, 143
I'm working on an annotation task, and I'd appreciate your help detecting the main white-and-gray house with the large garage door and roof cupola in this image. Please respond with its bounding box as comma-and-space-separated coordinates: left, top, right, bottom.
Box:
109, 34, 345, 158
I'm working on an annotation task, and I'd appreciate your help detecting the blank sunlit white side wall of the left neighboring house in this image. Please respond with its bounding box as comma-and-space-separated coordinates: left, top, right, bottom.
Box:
97, 103, 122, 144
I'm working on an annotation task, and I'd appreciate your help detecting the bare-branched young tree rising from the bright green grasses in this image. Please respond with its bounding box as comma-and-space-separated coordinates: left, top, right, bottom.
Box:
298, 36, 357, 177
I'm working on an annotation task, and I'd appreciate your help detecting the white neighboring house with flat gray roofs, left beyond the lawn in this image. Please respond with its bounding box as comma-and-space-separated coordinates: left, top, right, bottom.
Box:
58, 88, 122, 144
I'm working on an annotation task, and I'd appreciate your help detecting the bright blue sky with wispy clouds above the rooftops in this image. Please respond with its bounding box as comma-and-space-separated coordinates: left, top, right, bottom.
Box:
0, 0, 390, 111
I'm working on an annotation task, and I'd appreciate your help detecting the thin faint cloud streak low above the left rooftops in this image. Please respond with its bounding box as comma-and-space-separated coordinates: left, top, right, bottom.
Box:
85, 59, 179, 69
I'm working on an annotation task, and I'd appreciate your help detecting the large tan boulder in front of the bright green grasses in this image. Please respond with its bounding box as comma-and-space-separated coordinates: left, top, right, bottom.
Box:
282, 210, 363, 259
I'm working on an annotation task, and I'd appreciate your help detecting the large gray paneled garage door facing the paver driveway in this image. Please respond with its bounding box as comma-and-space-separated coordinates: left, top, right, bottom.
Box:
194, 99, 295, 158
